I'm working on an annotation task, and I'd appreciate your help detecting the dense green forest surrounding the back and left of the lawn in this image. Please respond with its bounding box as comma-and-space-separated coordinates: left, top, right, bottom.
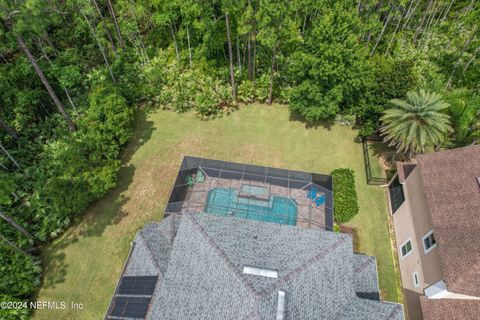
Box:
0, 0, 480, 319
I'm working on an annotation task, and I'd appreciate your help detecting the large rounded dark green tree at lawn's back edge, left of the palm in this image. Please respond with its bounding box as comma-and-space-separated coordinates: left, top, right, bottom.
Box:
288, 3, 369, 121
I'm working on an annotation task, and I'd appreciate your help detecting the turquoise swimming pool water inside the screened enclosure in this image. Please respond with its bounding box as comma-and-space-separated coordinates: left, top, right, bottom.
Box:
205, 188, 297, 226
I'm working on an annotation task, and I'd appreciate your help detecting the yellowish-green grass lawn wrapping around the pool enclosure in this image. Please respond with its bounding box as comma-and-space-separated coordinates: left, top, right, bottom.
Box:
33, 105, 401, 319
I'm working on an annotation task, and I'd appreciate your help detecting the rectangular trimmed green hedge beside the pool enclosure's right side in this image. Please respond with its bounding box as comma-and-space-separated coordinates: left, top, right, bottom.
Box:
331, 168, 358, 223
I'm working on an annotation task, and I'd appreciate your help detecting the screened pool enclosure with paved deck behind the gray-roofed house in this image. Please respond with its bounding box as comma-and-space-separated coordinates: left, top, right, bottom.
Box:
166, 156, 333, 230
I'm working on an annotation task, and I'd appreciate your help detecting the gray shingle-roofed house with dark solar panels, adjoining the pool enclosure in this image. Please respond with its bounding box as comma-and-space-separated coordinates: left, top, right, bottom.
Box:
106, 213, 403, 320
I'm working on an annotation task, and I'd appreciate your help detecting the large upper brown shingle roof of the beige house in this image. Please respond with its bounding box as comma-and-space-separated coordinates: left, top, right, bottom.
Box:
417, 145, 480, 296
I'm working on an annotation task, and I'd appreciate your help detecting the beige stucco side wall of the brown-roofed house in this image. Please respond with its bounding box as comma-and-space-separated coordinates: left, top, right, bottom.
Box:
393, 168, 443, 320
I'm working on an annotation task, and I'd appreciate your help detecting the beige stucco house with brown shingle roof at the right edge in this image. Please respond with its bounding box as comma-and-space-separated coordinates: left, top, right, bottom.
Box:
388, 146, 480, 320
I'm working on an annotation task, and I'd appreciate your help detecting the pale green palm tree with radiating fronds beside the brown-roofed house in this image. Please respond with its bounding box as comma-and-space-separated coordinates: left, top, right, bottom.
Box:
380, 90, 452, 157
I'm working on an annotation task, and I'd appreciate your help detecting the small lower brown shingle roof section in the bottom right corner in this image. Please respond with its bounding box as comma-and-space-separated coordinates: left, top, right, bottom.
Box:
420, 297, 480, 320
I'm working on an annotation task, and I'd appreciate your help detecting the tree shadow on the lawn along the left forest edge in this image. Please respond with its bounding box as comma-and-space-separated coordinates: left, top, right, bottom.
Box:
36, 110, 155, 290
